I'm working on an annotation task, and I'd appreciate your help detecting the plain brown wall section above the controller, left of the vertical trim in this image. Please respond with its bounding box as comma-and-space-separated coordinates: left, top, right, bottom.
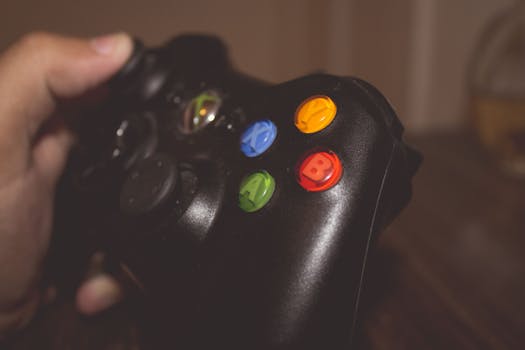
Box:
0, 0, 332, 80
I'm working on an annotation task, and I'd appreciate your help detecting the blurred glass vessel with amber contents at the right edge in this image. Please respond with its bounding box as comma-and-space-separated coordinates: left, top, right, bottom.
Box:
470, 0, 525, 178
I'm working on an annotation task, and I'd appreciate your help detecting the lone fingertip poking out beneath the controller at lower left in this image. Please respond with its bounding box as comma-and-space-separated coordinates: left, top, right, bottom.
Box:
76, 274, 123, 315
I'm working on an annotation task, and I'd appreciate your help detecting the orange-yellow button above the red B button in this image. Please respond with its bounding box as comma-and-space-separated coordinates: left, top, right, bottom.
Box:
295, 96, 337, 134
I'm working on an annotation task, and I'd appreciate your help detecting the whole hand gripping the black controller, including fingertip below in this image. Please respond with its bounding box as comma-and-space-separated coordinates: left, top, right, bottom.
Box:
0, 33, 132, 338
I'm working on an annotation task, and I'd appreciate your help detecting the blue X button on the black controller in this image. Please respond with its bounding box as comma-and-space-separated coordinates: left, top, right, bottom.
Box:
241, 120, 277, 157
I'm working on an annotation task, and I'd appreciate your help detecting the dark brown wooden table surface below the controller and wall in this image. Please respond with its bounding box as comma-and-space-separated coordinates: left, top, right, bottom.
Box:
4, 133, 525, 350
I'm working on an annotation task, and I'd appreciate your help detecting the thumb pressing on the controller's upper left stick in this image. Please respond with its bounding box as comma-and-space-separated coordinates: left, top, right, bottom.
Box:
0, 33, 133, 130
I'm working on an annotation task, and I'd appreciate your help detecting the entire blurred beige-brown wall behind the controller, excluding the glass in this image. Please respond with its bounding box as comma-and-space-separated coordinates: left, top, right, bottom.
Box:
0, 0, 512, 131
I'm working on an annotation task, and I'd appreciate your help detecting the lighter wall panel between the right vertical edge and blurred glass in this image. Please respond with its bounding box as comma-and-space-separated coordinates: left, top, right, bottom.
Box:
406, 0, 516, 131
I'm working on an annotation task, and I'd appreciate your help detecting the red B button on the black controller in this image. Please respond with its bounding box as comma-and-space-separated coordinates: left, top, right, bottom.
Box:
297, 151, 343, 192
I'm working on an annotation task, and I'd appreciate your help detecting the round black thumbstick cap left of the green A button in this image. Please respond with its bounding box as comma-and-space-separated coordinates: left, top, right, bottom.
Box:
120, 154, 178, 215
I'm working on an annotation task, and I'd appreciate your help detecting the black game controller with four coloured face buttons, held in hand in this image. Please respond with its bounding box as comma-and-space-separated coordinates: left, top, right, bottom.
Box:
51, 36, 420, 350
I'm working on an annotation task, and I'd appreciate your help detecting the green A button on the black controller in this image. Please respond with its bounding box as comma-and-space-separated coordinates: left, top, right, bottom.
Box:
239, 171, 275, 213
